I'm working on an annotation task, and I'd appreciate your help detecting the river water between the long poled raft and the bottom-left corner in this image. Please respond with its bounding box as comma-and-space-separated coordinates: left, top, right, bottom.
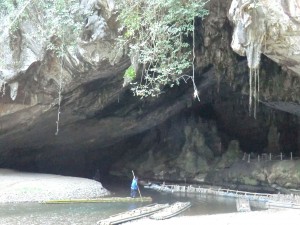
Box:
0, 203, 148, 225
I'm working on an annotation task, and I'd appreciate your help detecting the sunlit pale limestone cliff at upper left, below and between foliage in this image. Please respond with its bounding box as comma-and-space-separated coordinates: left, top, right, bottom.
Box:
0, 0, 123, 115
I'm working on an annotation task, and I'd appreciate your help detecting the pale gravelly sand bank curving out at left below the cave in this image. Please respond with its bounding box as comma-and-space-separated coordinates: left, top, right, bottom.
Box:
0, 169, 109, 203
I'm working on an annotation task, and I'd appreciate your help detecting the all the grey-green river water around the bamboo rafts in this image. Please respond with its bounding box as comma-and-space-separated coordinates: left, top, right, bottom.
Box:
0, 180, 262, 225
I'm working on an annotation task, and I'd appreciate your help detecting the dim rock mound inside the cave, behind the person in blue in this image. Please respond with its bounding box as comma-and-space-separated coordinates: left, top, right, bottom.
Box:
110, 115, 222, 182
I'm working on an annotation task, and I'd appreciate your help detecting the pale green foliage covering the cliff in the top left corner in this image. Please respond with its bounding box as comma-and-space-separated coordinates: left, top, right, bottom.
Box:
0, 0, 86, 57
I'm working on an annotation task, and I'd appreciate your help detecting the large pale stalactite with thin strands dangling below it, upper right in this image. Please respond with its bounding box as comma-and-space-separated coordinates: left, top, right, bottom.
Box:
229, 0, 266, 118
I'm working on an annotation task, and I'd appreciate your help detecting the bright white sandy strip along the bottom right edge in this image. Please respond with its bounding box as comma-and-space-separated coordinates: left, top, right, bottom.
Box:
126, 209, 300, 225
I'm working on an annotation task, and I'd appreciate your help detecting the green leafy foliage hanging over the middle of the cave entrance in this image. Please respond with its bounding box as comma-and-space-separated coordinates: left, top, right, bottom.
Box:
117, 0, 208, 97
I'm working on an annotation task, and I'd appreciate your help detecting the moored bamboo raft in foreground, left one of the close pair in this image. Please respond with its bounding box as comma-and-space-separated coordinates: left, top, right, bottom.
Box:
97, 204, 169, 225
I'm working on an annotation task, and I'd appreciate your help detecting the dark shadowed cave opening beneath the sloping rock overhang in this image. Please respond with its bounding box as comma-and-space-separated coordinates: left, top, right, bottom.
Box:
1, 99, 299, 181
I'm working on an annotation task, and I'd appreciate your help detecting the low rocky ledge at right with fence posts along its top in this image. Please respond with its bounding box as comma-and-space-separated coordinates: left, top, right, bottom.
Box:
207, 159, 300, 192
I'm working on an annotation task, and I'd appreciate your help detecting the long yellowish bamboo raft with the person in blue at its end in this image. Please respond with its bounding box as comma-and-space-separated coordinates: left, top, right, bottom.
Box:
41, 197, 152, 204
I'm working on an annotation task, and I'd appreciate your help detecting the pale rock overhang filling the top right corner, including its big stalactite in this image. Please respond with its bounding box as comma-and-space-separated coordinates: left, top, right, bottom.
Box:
228, 0, 300, 115
